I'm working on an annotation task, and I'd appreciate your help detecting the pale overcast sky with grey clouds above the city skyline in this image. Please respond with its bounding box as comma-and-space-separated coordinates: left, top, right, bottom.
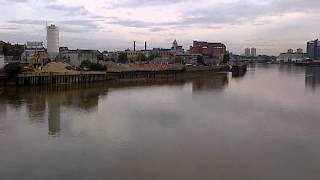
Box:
0, 0, 320, 55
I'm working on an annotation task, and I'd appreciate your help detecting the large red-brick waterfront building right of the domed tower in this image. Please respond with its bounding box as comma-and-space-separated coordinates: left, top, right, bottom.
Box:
189, 41, 227, 62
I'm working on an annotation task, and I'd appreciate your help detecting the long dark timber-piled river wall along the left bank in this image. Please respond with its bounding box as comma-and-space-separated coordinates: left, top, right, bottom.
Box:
0, 65, 230, 86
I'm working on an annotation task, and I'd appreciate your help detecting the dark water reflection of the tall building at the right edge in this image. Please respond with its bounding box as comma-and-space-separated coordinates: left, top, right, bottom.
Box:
306, 66, 320, 89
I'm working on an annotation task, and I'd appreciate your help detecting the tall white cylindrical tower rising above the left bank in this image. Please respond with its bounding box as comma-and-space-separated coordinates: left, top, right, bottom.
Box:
47, 24, 59, 59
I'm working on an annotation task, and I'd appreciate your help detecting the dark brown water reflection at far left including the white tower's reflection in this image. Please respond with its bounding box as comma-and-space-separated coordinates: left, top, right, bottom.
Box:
0, 84, 108, 136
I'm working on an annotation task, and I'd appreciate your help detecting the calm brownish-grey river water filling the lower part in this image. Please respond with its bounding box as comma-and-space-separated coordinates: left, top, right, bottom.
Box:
0, 65, 320, 180
